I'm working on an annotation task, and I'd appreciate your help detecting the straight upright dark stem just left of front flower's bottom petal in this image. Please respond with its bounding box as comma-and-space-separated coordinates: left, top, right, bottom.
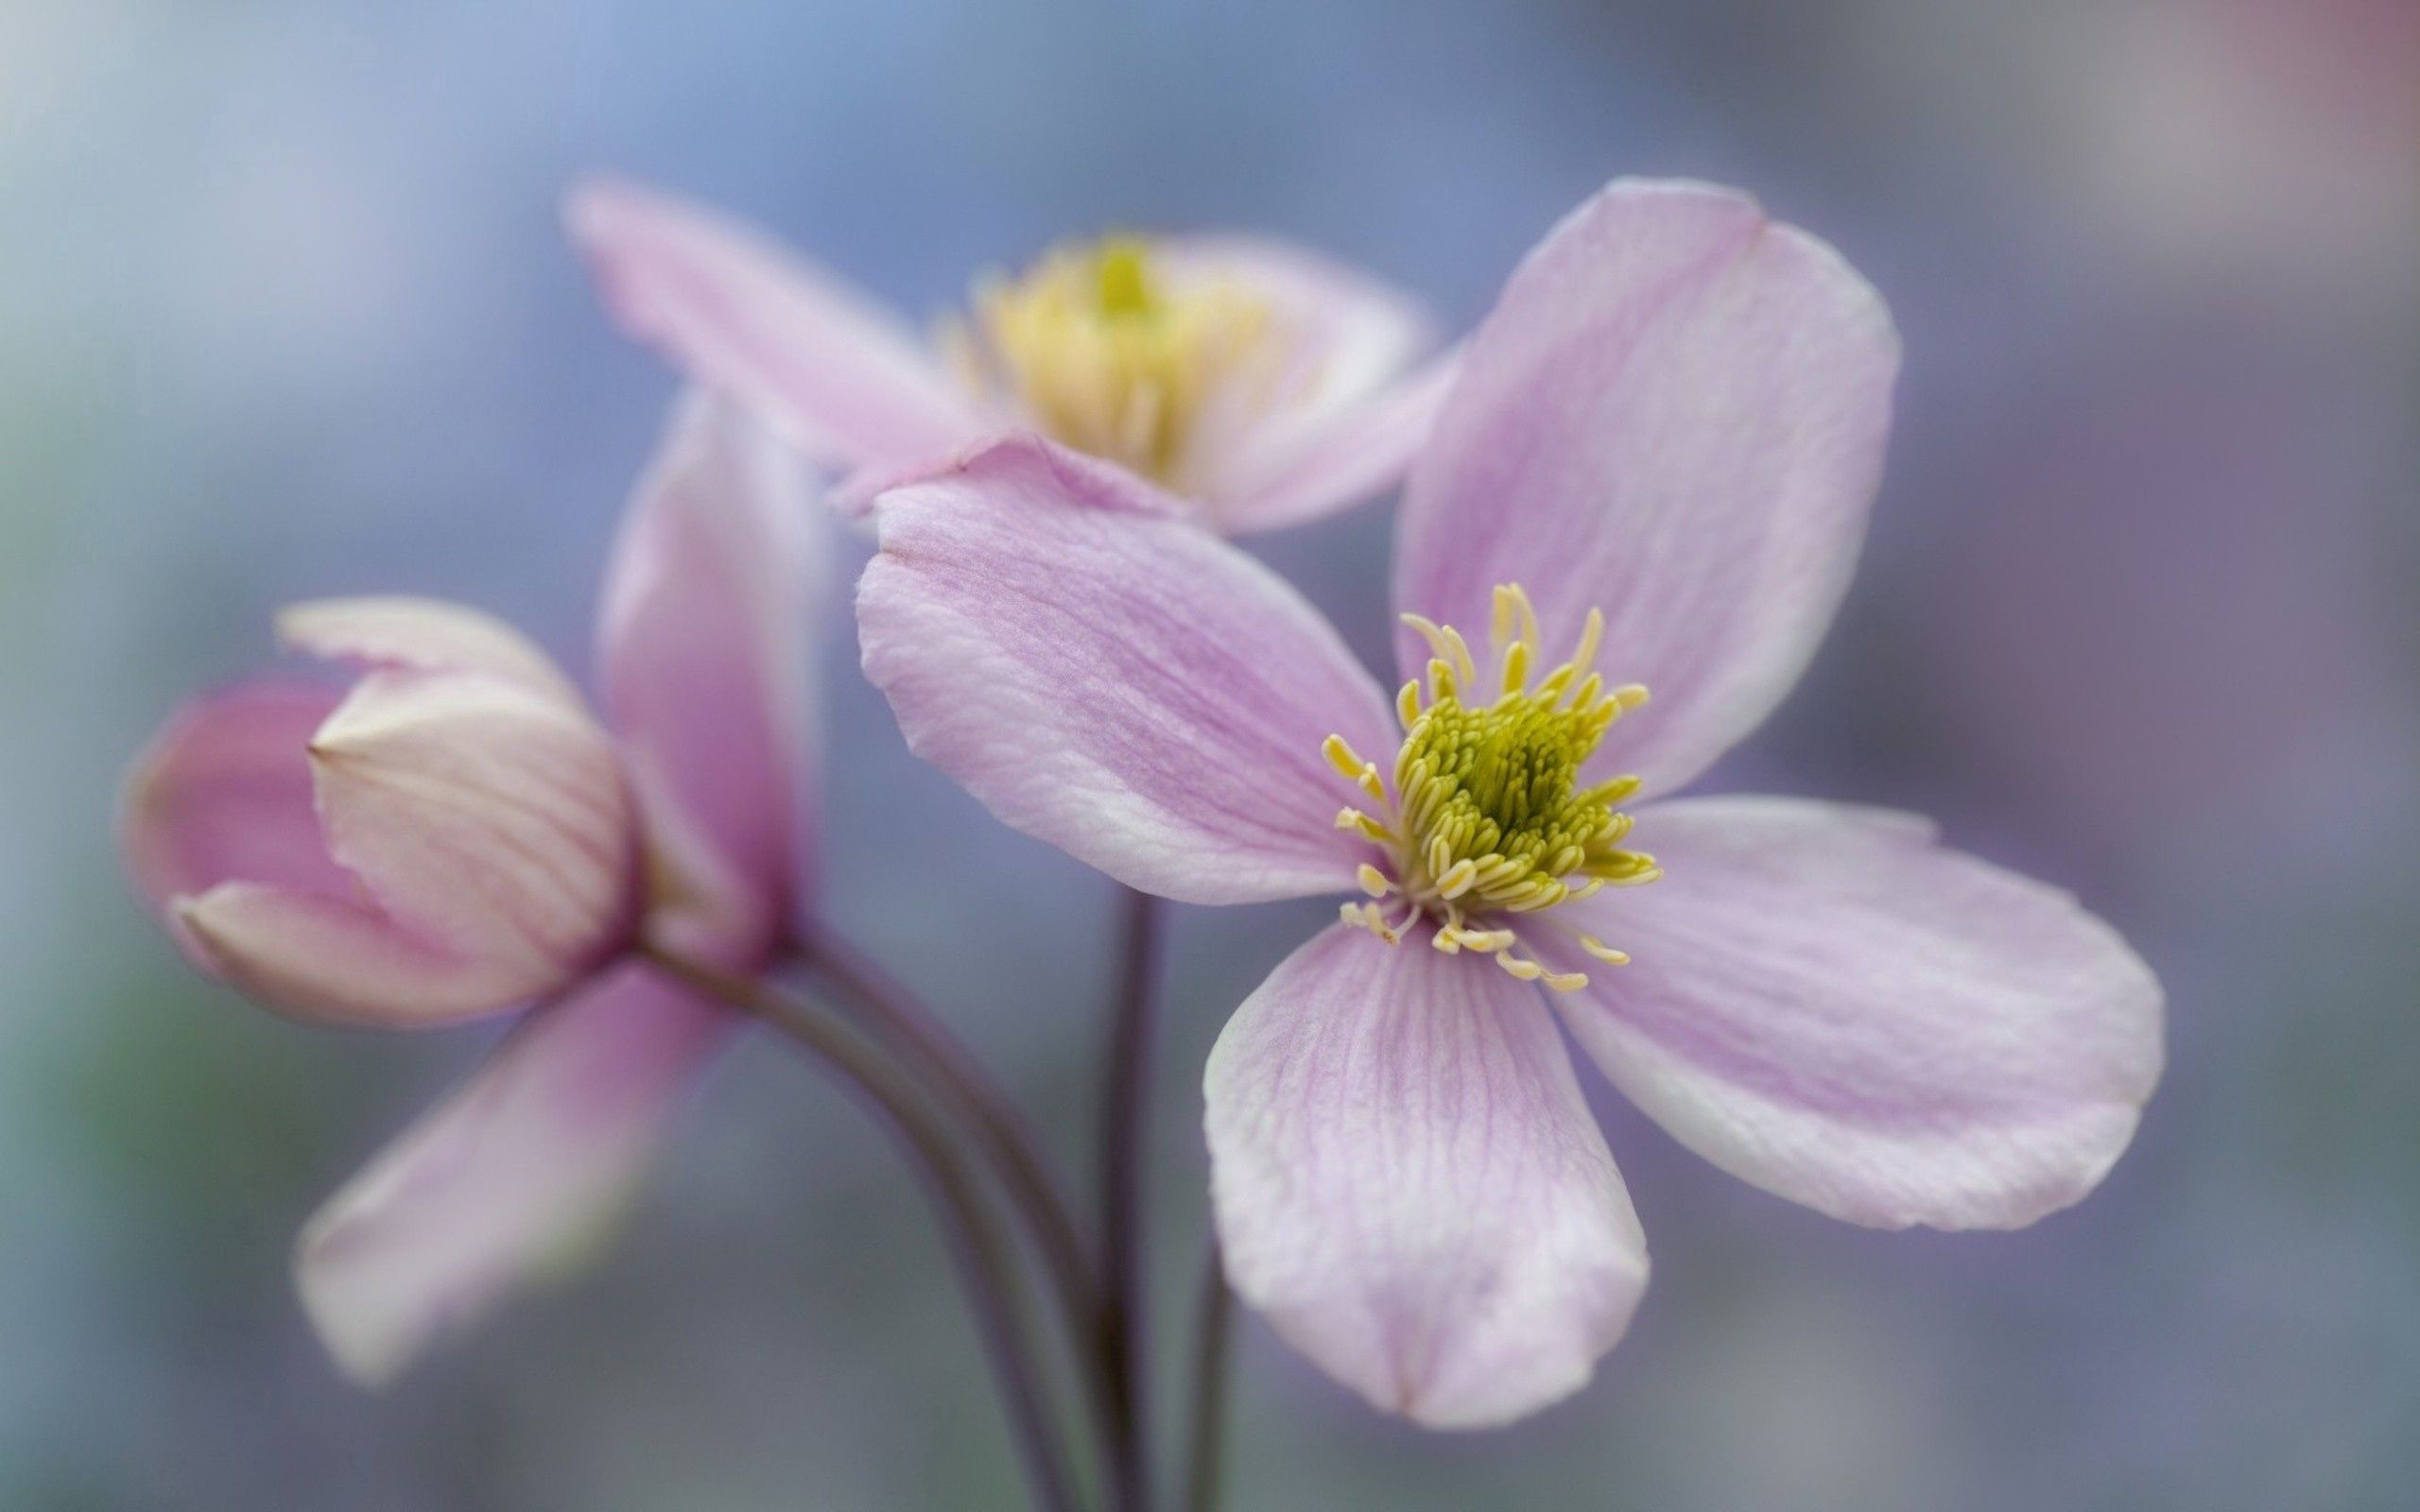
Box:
1098, 890, 1159, 1509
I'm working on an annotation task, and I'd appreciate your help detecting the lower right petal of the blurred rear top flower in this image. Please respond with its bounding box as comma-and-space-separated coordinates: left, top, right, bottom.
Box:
1202, 355, 1457, 535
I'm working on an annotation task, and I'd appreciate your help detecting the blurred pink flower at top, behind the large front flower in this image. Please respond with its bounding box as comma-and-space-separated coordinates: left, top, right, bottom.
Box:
566, 181, 1449, 532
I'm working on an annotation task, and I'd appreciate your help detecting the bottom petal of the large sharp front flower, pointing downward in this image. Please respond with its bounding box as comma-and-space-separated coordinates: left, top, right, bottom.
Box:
1202, 924, 1648, 1427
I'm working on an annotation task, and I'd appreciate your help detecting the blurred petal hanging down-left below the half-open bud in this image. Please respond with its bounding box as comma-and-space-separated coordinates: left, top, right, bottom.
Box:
295, 968, 735, 1383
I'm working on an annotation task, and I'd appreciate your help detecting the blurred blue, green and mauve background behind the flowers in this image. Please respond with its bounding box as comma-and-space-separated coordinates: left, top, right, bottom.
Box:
0, 0, 2420, 1512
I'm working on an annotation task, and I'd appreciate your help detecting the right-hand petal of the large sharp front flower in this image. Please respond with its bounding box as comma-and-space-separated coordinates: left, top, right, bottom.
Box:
1556, 799, 2161, 1228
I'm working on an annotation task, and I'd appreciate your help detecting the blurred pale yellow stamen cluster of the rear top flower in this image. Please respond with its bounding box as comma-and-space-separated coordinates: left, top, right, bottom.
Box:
942, 237, 1278, 487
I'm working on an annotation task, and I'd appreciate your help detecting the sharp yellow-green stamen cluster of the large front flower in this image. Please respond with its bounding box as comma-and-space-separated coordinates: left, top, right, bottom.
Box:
1322, 583, 1663, 992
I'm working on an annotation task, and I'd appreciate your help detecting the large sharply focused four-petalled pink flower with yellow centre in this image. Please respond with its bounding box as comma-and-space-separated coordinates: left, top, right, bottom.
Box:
856, 184, 2161, 1427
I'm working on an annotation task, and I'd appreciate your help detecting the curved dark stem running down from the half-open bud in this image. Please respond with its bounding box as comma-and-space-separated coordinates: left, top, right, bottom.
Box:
639, 946, 1075, 1512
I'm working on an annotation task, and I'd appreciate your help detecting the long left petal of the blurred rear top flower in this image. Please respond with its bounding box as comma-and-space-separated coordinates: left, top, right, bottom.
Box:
563, 179, 985, 467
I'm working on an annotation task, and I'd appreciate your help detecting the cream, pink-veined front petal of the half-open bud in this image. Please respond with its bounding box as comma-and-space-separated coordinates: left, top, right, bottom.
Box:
310, 670, 639, 994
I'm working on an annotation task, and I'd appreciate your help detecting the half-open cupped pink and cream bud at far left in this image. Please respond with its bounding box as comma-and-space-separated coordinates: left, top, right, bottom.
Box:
124, 597, 639, 1025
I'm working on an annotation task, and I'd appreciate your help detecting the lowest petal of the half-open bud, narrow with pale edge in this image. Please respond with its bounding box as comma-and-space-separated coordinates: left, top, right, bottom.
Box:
169, 881, 569, 1028
